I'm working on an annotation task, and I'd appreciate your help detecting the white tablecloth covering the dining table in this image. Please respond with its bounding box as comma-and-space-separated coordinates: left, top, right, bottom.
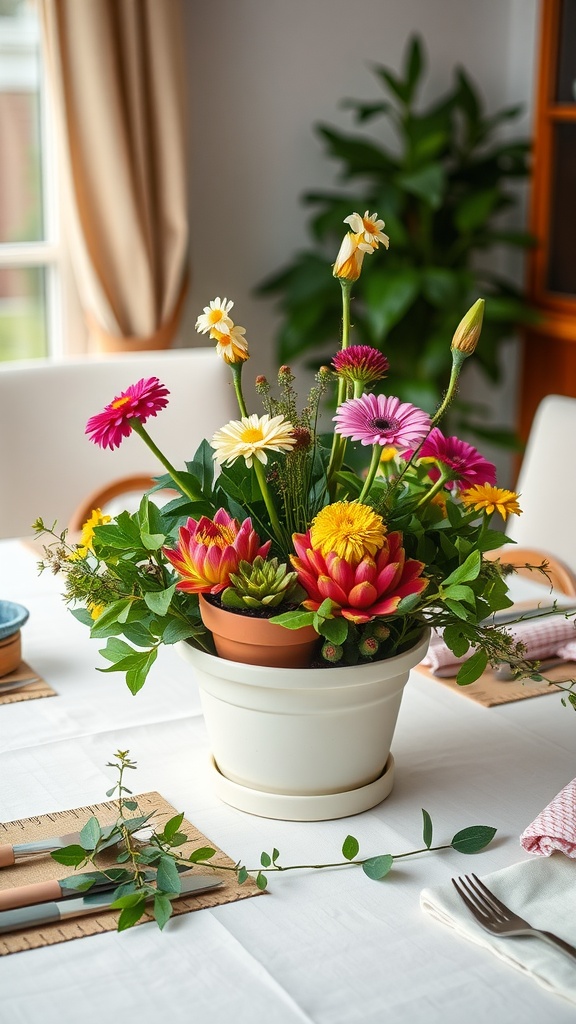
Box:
0, 541, 576, 1024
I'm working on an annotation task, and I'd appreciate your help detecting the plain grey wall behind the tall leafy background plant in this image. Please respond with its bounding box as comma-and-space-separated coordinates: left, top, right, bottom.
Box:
184, 0, 537, 485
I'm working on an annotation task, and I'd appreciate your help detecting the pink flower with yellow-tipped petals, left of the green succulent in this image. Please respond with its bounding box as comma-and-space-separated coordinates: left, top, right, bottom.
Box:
164, 509, 272, 594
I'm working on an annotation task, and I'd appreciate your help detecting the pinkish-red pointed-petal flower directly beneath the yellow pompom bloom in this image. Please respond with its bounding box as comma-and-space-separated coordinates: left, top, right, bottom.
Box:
290, 530, 428, 625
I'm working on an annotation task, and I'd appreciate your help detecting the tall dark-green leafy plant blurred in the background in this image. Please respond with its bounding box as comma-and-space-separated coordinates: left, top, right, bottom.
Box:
258, 36, 535, 444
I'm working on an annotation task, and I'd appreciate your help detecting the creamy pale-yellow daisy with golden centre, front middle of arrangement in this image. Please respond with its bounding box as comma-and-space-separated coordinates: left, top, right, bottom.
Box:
210, 413, 296, 468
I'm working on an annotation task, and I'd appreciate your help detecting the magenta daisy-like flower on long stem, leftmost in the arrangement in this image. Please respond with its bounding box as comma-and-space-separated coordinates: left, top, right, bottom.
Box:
85, 377, 170, 449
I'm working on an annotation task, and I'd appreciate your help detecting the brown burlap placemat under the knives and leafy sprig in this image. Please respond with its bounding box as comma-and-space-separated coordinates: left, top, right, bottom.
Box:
0, 793, 261, 955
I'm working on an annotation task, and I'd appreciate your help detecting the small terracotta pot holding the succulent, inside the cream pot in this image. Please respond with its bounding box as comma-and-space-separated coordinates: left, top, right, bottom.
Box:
200, 595, 319, 669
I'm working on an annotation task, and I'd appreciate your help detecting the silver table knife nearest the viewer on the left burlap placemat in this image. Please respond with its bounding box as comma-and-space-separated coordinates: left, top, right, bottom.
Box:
0, 874, 222, 935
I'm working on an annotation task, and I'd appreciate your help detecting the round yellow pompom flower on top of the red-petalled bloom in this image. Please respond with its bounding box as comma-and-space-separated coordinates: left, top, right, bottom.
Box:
311, 502, 386, 564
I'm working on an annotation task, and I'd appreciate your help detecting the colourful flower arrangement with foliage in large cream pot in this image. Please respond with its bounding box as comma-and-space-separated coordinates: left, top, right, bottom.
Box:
37, 211, 522, 817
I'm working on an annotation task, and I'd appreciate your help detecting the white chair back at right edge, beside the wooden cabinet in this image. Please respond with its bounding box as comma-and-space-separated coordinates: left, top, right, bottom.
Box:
502, 394, 576, 572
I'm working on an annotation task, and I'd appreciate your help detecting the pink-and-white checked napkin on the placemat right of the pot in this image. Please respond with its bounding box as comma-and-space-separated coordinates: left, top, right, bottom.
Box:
422, 614, 576, 675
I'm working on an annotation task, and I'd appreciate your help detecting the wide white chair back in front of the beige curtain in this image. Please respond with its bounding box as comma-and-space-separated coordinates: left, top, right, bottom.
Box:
0, 348, 239, 537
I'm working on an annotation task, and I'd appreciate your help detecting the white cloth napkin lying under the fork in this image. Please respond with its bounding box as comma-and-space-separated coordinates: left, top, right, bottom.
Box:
420, 853, 576, 1005
